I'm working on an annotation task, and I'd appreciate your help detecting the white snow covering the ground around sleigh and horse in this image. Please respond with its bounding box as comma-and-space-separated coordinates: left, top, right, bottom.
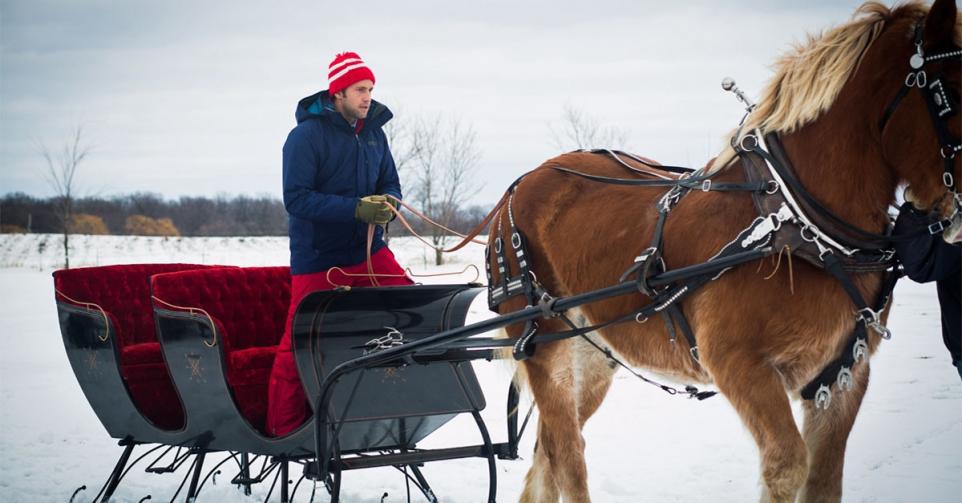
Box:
0, 234, 962, 503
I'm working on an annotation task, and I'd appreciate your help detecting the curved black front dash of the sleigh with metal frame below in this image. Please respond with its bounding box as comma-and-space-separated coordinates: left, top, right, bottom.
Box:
293, 285, 530, 502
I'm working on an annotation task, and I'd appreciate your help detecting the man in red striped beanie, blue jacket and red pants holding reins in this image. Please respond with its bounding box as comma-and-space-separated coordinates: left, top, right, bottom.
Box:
266, 52, 413, 436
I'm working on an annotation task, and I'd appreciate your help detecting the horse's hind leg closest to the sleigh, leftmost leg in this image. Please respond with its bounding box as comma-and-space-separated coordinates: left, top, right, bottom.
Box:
520, 334, 590, 503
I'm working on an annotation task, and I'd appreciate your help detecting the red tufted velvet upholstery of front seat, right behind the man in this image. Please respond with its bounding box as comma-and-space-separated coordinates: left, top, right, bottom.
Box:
151, 267, 291, 438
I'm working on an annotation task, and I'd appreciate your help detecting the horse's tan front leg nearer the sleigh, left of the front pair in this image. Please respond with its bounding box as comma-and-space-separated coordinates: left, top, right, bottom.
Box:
711, 353, 808, 502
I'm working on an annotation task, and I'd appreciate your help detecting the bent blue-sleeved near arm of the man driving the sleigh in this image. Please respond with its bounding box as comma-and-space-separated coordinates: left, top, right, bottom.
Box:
284, 127, 357, 222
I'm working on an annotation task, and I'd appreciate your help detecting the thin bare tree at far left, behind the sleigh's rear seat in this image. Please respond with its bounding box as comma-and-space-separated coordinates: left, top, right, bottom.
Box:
38, 125, 90, 269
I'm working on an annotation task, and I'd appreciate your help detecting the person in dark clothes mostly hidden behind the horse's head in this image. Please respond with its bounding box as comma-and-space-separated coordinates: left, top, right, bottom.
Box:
892, 197, 962, 377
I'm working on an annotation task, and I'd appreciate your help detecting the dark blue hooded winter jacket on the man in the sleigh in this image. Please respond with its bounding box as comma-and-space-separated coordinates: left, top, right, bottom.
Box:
284, 91, 401, 274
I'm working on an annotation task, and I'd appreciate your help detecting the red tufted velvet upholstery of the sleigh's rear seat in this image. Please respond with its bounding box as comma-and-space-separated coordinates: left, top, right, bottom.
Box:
53, 264, 218, 430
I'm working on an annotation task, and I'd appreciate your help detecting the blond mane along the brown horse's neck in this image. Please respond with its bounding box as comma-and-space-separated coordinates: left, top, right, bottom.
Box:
711, 1, 944, 171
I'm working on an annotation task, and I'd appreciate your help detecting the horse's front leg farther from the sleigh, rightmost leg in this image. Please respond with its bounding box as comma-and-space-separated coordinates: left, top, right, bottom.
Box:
801, 363, 869, 501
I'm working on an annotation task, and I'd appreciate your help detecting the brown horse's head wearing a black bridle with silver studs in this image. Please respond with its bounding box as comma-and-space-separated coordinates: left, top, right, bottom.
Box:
861, 0, 962, 242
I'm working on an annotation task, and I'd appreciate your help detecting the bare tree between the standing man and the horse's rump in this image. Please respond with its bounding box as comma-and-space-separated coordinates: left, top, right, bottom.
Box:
408, 116, 481, 265
